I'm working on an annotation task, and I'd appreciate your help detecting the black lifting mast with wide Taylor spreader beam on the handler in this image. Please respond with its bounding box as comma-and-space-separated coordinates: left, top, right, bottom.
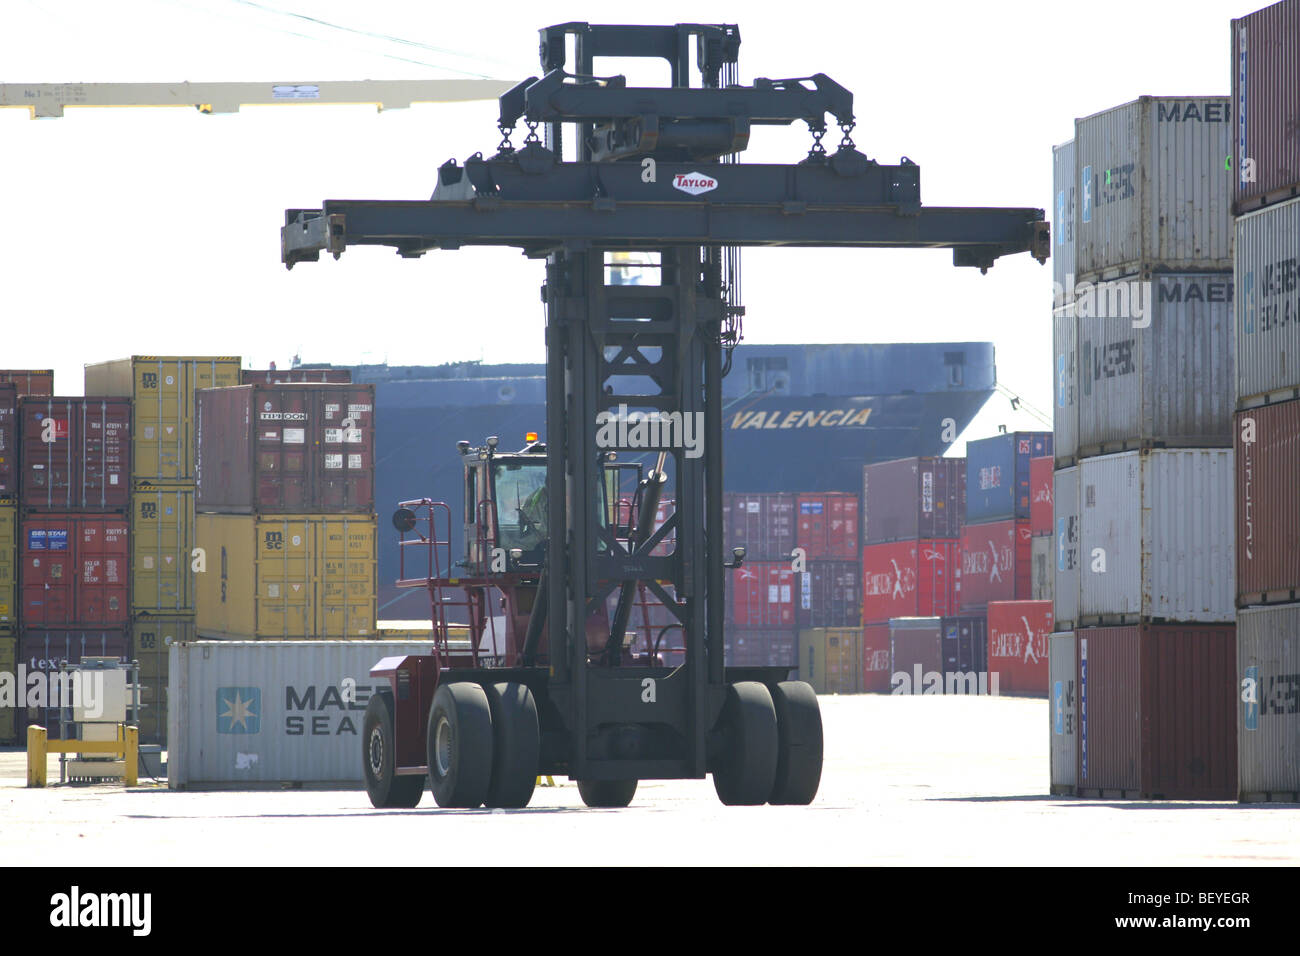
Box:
282, 22, 1049, 803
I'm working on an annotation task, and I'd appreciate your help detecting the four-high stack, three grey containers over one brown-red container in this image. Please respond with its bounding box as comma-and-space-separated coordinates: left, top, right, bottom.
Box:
1049, 89, 1236, 799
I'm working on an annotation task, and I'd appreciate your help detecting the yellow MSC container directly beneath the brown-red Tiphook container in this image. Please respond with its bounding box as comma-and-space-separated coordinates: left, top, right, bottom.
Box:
195, 514, 377, 640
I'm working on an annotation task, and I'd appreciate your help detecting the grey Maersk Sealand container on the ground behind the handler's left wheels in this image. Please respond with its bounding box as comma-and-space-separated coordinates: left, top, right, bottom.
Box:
168, 641, 433, 790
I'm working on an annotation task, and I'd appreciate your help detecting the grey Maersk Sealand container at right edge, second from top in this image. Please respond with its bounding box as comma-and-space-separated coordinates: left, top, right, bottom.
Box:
1234, 199, 1300, 407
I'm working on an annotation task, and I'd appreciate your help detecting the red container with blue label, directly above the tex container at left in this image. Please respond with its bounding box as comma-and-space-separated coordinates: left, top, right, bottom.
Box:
18, 514, 131, 627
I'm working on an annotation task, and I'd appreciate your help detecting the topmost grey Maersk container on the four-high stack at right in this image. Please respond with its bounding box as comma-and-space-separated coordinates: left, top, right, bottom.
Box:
1074, 96, 1234, 280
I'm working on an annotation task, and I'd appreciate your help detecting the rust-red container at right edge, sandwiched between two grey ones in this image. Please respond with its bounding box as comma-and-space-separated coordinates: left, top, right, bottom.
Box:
1235, 401, 1300, 606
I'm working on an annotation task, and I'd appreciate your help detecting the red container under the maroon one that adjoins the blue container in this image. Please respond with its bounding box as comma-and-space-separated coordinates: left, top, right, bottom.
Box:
862, 538, 962, 624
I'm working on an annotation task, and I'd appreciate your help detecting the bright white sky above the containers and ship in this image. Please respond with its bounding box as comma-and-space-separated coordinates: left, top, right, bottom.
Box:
0, 0, 1265, 453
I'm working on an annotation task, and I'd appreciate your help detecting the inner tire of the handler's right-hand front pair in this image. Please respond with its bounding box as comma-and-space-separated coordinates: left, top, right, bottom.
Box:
714, 680, 780, 806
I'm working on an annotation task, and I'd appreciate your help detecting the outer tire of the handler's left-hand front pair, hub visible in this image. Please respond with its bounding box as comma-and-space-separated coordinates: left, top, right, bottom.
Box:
428, 680, 493, 808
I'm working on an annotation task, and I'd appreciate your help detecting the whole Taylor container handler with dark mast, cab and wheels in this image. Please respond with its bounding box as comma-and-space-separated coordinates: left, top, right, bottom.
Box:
281, 22, 1049, 808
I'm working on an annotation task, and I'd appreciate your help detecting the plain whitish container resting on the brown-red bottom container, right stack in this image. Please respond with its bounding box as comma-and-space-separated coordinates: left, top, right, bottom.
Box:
1079, 449, 1236, 626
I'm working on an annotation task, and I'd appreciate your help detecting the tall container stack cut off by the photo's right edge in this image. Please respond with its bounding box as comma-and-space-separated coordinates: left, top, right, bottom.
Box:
1232, 0, 1300, 803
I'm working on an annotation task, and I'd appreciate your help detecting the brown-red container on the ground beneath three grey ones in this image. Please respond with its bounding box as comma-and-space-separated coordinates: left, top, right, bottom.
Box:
1075, 624, 1239, 800
